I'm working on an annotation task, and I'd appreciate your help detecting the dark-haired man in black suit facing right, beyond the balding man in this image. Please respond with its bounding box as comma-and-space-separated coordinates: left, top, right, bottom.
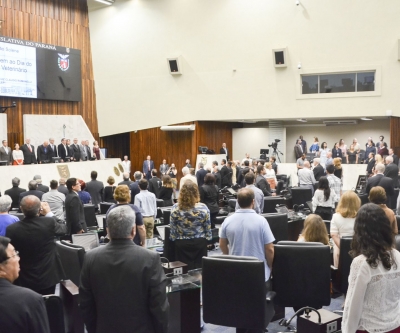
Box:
65, 178, 85, 235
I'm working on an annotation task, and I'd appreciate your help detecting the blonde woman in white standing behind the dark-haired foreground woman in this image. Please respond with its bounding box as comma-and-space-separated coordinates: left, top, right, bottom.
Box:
330, 191, 361, 267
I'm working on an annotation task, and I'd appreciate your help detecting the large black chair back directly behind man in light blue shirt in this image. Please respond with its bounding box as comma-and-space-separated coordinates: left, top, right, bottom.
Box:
202, 256, 274, 331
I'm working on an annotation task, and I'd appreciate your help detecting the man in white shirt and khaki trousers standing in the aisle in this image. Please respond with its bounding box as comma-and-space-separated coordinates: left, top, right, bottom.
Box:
135, 179, 157, 239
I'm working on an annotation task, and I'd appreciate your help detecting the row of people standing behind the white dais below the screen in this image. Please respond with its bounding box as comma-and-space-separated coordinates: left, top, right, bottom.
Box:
0, 138, 100, 165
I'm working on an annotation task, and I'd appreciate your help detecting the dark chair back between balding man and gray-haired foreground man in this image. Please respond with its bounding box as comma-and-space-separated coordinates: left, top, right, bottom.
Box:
56, 241, 85, 286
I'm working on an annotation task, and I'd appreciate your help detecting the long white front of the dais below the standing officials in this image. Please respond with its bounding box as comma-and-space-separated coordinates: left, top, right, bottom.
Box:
0, 158, 123, 195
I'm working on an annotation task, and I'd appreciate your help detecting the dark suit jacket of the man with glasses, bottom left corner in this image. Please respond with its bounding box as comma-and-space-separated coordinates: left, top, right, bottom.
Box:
0, 279, 50, 333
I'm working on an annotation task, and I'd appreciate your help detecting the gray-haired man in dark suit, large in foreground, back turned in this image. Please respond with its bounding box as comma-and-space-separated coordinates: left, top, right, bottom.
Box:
79, 206, 169, 333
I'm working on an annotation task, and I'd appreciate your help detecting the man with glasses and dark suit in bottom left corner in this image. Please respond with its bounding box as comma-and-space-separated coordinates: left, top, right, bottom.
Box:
0, 236, 50, 333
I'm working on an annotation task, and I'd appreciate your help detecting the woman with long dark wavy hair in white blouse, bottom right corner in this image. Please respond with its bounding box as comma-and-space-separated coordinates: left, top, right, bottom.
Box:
342, 204, 400, 333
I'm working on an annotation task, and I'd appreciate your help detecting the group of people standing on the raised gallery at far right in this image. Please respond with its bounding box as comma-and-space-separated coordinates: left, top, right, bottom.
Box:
294, 135, 393, 165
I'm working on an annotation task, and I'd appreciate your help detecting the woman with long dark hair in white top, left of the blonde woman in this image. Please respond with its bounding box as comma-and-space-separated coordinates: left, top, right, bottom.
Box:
312, 177, 338, 221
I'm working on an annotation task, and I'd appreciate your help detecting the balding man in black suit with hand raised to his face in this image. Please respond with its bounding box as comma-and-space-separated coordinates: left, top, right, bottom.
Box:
6, 195, 67, 295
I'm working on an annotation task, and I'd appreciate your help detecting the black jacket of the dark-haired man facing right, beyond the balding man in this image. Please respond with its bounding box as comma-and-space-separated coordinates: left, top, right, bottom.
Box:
65, 191, 86, 235
